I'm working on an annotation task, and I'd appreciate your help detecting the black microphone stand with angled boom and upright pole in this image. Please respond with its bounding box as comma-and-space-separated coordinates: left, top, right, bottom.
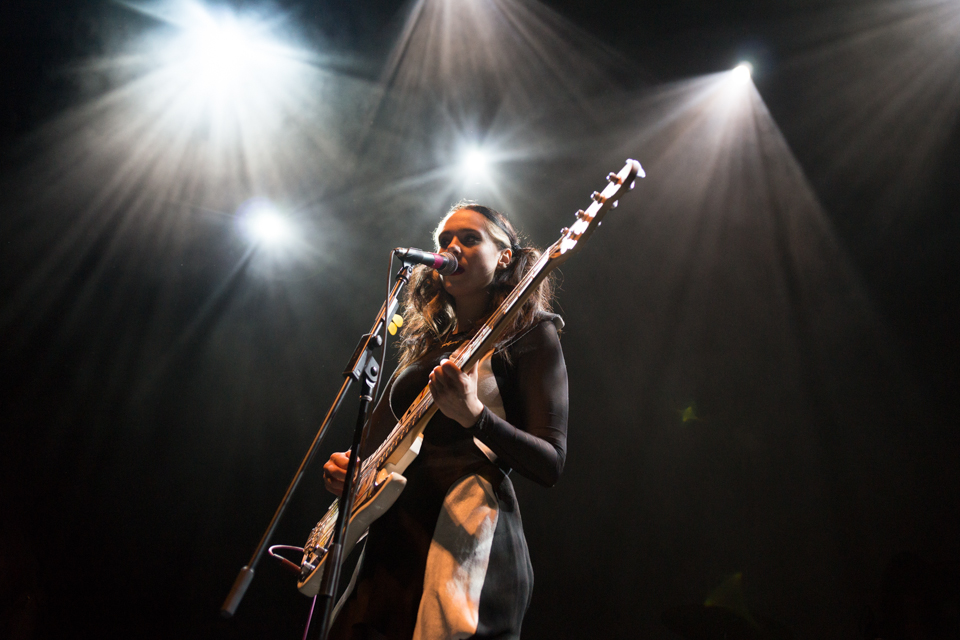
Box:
220, 262, 411, 624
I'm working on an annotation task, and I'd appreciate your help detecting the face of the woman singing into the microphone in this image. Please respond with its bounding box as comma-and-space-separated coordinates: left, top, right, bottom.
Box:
437, 209, 511, 302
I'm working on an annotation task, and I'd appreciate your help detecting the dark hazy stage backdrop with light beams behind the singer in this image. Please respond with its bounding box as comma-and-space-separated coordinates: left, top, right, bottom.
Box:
0, 0, 960, 638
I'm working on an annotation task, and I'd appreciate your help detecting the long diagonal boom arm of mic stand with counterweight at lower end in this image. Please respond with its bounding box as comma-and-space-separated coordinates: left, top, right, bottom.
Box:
220, 264, 410, 618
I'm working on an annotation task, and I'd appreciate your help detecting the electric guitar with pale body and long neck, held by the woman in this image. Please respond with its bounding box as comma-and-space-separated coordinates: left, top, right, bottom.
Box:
297, 160, 643, 596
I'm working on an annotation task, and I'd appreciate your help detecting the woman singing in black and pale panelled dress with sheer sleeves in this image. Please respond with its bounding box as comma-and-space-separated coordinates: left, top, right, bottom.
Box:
324, 203, 567, 640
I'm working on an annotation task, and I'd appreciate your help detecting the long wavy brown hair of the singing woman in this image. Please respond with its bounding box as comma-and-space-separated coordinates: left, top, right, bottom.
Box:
399, 200, 554, 369
